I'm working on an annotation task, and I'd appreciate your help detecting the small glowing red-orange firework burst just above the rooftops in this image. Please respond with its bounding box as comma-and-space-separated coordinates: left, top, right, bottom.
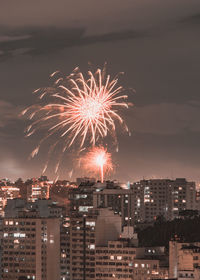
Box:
80, 146, 113, 183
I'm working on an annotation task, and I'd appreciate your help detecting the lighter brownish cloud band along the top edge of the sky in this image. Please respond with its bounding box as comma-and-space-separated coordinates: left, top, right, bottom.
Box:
0, 0, 199, 30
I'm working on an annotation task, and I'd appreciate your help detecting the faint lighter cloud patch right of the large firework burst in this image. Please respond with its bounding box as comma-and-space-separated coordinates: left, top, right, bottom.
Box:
131, 102, 200, 135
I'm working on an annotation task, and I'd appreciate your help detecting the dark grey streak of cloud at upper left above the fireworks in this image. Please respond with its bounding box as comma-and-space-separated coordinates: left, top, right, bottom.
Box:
0, 27, 147, 58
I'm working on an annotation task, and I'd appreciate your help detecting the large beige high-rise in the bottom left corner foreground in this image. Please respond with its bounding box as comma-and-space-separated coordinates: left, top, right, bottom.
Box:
2, 211, 60, 280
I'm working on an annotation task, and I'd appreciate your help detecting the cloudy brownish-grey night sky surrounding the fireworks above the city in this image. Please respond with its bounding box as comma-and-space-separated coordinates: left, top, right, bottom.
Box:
0, 0, 200, 181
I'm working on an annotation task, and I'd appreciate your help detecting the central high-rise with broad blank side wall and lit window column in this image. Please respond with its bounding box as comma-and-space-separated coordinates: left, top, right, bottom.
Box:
70, 208, 121, 280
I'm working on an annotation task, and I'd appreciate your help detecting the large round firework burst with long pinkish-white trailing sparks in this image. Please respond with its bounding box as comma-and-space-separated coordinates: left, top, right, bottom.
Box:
22, 67, 130, 174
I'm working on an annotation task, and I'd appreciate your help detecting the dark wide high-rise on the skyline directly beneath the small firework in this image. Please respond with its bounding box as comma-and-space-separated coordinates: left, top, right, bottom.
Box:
69, 181, 134, 226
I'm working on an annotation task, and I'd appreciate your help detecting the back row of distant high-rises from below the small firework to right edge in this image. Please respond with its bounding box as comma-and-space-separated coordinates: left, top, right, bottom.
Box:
69, 179, 200, 225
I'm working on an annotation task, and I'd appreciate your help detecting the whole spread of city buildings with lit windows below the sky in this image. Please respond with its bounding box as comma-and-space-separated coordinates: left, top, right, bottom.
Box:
0, 176, 200, 280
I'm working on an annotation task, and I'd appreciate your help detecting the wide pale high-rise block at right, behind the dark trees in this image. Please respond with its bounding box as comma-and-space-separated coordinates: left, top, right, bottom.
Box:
131, 178, 197, 222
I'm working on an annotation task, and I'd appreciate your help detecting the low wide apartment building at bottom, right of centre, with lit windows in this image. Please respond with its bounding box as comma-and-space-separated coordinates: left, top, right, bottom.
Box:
95, 239, 168, 280
